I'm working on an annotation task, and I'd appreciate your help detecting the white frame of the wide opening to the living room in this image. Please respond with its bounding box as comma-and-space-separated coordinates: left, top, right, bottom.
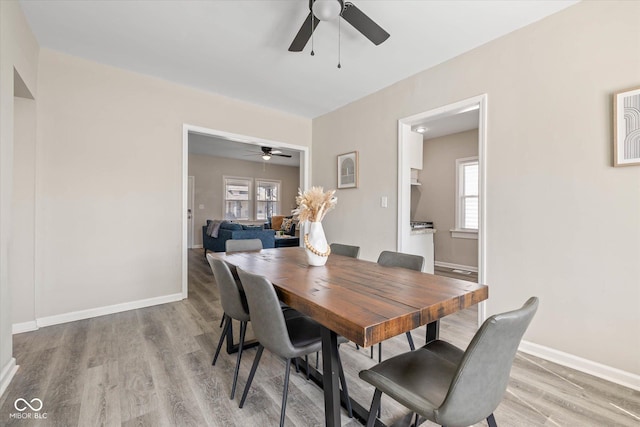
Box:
180, 123, 311, 299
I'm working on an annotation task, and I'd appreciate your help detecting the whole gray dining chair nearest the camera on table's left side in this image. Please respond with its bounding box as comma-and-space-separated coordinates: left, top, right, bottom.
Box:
238, 268, 351, 427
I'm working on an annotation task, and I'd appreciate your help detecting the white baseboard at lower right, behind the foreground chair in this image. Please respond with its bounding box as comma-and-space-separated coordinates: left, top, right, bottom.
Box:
518, 341, 640, 391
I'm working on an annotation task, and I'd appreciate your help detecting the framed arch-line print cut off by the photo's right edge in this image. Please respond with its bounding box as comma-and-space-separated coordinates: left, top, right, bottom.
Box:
613, 87, 640, 166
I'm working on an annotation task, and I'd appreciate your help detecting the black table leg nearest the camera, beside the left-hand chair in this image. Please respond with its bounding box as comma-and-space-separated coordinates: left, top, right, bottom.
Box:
322, 326, 341, 427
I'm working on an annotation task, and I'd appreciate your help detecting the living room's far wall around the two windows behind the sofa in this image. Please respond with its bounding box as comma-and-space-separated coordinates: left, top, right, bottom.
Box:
189, 154, 300, 246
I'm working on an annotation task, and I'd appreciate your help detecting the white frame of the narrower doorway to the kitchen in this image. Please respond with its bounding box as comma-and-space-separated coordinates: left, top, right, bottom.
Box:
397, 93, 488, 326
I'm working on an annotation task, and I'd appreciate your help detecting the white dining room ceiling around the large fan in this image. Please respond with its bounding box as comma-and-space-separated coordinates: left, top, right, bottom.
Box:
20, 0, 577, 118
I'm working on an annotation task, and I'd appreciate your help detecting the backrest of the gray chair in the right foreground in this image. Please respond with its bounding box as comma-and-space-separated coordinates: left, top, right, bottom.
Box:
437, 297, 538, 425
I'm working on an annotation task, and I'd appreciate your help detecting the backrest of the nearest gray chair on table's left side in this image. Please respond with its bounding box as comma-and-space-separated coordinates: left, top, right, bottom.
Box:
237, 268, 295, 358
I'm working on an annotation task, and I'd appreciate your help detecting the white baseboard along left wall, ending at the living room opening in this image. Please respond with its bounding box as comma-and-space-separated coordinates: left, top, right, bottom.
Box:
13, 293, 184, 334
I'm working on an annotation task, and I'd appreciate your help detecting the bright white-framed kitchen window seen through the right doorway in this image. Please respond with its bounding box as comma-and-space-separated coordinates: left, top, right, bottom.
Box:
452, 157, 480, 239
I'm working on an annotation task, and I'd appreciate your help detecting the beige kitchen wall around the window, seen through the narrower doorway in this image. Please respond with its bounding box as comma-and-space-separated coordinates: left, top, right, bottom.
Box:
411, 129, 478, 267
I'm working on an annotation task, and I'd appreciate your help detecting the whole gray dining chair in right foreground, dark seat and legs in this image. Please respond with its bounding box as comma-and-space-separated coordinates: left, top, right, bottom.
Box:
360, 297, 538, 427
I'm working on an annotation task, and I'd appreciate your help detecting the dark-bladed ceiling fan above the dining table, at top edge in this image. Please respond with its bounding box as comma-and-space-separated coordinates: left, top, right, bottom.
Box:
289, 0, 389, 52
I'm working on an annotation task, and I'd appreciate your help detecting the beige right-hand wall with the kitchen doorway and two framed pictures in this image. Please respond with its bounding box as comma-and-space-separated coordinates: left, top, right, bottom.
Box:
313, 1, 640, 381
